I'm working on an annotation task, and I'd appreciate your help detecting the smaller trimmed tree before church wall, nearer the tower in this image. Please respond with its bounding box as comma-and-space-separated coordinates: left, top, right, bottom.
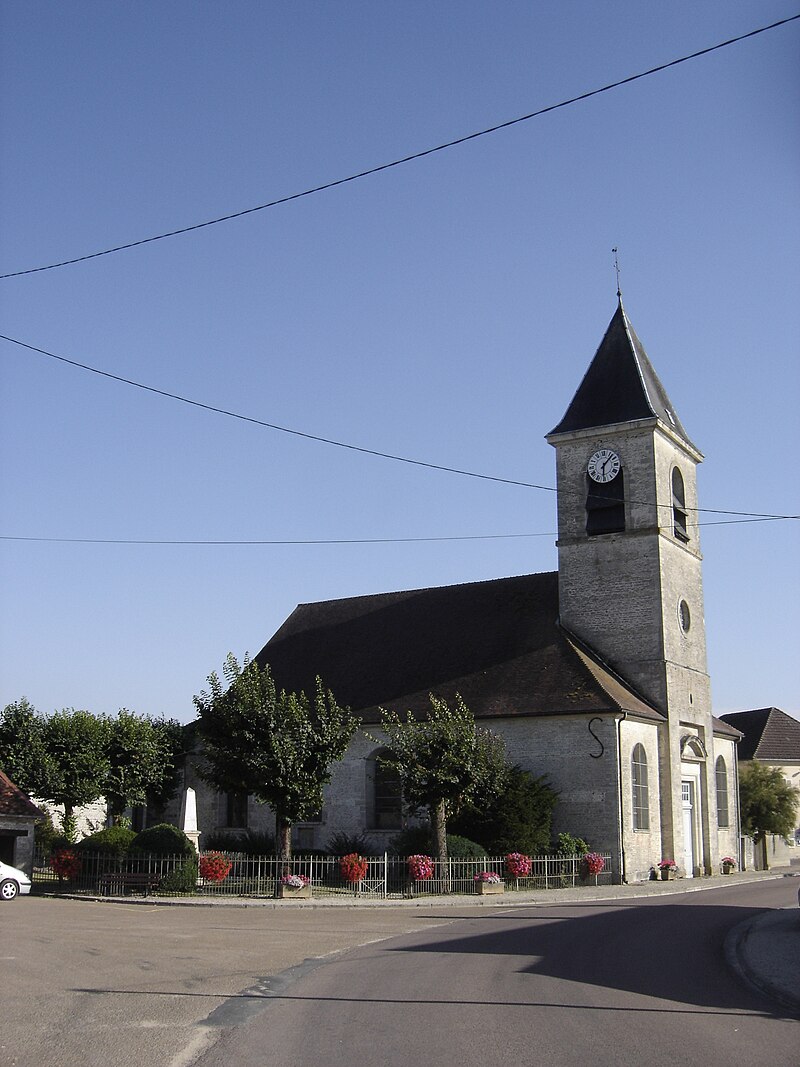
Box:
381, 694, 508, 861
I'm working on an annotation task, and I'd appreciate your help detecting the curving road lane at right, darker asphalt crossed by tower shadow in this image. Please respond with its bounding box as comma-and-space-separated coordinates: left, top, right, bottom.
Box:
198, 882, 800, 1067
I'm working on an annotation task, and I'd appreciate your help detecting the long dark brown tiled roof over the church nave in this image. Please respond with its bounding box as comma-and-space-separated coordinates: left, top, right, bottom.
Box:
256, 573, 663, 722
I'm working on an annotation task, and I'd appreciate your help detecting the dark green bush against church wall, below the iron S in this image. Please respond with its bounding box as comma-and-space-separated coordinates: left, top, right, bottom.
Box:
449, 766, 558, 856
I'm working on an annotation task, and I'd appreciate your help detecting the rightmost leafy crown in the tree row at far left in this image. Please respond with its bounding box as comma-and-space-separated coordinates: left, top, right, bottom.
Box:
102, 707, 180, 819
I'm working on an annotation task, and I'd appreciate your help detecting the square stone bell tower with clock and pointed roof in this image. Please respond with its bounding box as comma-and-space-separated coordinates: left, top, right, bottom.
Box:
547, 300, 716, 873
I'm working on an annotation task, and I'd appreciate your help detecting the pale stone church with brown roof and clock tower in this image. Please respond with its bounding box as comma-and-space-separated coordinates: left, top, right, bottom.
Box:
184, 300, 740, 881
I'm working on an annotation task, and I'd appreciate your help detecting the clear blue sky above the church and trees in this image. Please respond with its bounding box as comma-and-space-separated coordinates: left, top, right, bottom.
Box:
0, 0, 800, 720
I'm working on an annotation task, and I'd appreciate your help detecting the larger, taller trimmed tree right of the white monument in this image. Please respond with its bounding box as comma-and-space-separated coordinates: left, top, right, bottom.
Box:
194, 654, 358, 860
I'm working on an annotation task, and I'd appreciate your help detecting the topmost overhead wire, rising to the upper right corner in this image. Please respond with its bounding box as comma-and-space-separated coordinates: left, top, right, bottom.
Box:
0, 14, 800, 281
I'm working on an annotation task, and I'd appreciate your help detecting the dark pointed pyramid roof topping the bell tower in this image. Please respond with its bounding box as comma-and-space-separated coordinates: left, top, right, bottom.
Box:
547, 301, 697, 450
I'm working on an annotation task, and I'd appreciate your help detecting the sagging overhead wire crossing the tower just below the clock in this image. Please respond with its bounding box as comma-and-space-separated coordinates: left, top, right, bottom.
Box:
0, 334, 800, 520
